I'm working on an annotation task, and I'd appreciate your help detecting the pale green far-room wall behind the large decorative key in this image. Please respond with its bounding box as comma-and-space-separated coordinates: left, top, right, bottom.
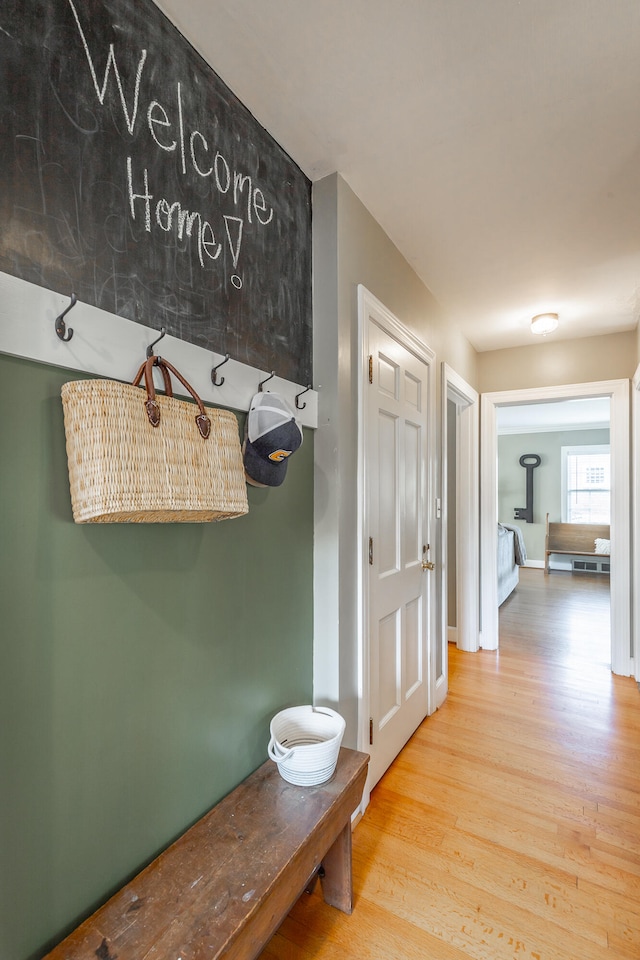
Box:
498, 429, 609, 563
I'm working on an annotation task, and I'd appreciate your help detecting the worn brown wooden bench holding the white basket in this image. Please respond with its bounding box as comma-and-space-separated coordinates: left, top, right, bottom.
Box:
45, 747, 369, 960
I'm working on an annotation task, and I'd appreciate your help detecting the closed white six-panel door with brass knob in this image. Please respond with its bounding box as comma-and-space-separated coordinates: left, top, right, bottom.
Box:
363, 298, 434, 786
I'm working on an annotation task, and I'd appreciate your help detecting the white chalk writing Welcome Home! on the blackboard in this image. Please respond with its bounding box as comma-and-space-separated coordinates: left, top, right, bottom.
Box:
68, 0, 274, 288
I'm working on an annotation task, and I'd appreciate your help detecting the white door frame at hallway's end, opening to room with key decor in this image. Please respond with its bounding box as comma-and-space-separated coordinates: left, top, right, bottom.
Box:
480, 380, 633, 676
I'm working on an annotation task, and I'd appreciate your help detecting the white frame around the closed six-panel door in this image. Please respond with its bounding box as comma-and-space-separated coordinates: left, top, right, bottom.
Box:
357, 284, 439, 811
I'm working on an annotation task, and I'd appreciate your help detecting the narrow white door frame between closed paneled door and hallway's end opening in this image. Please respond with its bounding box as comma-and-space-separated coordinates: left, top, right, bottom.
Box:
436, 362, 480, 664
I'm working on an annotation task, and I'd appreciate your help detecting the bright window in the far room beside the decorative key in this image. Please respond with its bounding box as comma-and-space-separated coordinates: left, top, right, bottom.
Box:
562, 444, 611, 523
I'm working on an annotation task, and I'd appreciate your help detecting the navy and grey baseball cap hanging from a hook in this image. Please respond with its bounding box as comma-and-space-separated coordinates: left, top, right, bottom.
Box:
242, 393, 302, 487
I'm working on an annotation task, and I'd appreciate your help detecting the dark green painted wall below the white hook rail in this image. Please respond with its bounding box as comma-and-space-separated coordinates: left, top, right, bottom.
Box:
0, 356, 313, 960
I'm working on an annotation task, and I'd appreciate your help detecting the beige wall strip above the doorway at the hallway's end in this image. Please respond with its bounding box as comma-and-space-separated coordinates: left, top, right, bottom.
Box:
477, 331, 638, 393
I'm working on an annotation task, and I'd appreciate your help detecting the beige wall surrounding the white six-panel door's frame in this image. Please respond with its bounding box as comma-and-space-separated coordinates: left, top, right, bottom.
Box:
313, 174, 477, 746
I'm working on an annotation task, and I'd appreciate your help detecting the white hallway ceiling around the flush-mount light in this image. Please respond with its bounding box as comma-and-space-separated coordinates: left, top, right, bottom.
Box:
158, 0, 640, 350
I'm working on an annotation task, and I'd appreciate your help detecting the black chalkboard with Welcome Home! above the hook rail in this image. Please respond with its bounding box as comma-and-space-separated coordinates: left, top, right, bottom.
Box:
0, 0, 311, 384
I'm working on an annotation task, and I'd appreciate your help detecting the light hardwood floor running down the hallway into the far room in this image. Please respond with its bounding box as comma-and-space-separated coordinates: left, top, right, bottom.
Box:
261, 569, 640, 960
